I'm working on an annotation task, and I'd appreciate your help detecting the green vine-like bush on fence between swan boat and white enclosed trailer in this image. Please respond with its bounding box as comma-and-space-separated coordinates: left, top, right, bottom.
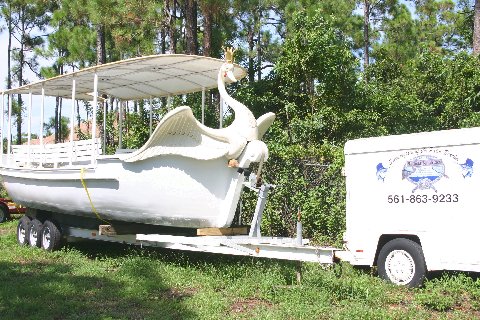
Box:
239, 122, 345, 244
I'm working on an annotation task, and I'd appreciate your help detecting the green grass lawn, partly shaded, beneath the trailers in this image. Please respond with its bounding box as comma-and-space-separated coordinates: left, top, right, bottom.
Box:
0, 221, 480, 319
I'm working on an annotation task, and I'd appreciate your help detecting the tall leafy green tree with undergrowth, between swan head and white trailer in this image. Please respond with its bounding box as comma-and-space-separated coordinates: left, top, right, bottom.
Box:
235, 10, 365, 239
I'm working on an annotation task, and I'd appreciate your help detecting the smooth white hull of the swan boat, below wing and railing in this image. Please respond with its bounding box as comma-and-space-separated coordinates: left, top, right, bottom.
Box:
1, 155, 248, 228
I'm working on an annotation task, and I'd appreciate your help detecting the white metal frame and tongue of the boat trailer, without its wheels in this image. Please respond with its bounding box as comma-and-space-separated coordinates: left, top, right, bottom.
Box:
63, 183, 339, 264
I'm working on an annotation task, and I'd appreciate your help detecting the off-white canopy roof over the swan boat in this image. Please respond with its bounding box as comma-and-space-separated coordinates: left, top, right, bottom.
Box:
2, 54, 246, 100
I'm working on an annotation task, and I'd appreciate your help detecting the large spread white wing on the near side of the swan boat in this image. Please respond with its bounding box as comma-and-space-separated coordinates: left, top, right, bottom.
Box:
123, 106, 246, 162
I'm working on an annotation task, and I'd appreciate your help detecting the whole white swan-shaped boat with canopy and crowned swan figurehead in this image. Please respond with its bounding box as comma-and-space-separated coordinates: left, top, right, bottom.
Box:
0, 48, 275, 228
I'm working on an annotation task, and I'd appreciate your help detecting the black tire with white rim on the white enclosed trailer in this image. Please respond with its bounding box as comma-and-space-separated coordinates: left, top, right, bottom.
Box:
377, 238, 427, 288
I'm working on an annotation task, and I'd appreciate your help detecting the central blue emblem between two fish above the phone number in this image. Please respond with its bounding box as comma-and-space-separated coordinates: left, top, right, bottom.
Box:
402, 155, 448, 193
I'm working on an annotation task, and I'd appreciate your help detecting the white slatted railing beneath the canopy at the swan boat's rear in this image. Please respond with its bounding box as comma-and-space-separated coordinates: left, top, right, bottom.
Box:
9, 138, 102, 168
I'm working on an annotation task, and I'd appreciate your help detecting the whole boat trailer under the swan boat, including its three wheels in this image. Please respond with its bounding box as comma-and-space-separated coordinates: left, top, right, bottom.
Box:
17, 179, 339, 264
